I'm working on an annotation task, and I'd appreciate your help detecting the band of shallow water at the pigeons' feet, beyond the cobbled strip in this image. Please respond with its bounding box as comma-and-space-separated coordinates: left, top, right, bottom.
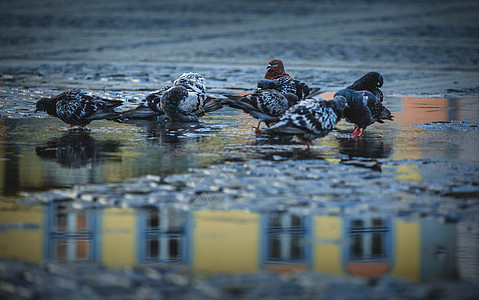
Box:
0, 94, 479, 196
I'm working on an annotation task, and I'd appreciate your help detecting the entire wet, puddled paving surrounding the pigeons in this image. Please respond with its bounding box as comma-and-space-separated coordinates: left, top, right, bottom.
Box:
0, 1, 479, 299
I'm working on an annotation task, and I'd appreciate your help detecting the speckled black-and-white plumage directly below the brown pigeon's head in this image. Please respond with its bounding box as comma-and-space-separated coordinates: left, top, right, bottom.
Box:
257, 77, 320, 100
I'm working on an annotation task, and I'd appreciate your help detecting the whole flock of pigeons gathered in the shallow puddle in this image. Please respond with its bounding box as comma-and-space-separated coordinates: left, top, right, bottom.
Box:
35, 59, 393, 149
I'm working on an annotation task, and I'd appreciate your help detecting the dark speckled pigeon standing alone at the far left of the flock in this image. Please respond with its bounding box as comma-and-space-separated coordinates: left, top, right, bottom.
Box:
35, 89, 124, 128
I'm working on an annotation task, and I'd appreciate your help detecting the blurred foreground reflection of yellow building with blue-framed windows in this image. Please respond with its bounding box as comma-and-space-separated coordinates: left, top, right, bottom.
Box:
0, 202, 479, 281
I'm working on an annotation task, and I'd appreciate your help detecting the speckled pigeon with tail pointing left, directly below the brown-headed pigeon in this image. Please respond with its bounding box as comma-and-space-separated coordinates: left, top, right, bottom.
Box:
223, 89, 298, 132
